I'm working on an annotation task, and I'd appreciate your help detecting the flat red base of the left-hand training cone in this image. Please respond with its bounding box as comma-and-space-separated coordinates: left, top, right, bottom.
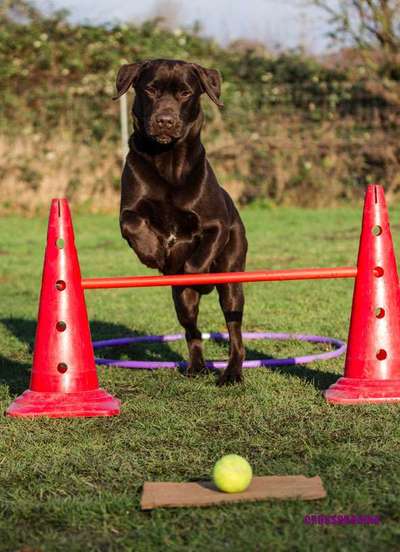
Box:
6, 389, 120, 418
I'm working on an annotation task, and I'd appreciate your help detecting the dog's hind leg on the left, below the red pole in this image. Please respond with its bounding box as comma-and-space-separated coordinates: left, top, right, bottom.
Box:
172, 287, 207, 376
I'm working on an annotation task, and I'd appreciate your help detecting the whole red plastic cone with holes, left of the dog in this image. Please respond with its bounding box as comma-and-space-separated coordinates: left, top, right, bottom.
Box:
7, 199, 120, 418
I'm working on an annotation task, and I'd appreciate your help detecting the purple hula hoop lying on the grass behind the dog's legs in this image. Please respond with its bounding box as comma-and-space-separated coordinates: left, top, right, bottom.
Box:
93, 332, 346, 370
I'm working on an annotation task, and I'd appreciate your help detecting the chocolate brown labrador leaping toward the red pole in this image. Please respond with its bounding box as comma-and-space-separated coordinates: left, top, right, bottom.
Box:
114, 59, 247, 385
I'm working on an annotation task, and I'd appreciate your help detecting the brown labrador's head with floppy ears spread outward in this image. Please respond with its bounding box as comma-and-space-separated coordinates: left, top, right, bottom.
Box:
113, 59, 223, 144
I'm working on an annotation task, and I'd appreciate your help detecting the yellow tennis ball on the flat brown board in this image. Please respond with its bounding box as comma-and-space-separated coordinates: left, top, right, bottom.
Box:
212, 454, 253, 493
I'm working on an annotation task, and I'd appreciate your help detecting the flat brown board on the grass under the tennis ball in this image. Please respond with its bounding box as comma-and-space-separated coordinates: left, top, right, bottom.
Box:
140, 475, 326, 510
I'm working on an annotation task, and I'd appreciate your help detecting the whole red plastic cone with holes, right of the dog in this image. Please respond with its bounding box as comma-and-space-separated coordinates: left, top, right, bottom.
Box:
325, 185, 400, 404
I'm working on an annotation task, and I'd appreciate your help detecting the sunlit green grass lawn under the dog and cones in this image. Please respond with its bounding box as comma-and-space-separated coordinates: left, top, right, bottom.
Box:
0, 208, 400, 552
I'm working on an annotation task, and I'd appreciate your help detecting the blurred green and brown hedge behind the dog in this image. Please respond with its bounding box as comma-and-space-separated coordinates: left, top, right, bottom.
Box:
0, 0, 400, 212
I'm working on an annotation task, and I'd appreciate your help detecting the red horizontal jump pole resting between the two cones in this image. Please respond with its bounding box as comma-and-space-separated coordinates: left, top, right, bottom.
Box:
82, 266, 357, 289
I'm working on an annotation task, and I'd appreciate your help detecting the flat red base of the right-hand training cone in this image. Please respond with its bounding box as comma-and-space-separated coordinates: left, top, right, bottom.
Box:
324, 377, 400, 404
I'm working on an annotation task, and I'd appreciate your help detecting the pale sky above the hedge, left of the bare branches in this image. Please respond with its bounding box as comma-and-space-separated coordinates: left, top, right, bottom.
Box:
36, 0, 328, 53
